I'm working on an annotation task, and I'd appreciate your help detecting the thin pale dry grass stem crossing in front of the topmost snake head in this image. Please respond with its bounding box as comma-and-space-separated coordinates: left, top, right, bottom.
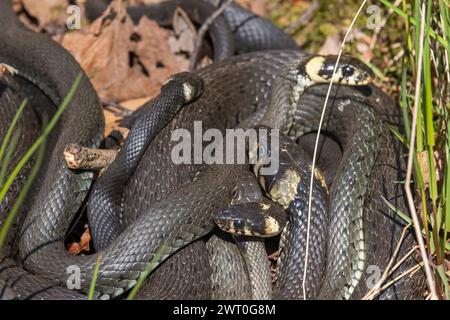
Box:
302, 0, 367, 300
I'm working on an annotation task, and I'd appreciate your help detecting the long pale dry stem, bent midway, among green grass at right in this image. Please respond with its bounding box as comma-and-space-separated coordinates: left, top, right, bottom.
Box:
405, 2, 438, 300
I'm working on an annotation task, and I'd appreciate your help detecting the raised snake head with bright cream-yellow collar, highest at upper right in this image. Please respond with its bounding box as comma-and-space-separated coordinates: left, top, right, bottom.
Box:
305, 55, 374, 86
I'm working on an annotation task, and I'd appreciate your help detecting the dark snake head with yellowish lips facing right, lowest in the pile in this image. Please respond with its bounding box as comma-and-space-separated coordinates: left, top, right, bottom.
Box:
213, 202, 282, 237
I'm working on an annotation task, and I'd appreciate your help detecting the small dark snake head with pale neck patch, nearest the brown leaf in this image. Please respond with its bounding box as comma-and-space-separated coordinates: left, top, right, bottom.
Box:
161, 72, 203, 103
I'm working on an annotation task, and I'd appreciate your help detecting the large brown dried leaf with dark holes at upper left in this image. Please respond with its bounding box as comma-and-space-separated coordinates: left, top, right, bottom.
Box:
62, 1, 180, 102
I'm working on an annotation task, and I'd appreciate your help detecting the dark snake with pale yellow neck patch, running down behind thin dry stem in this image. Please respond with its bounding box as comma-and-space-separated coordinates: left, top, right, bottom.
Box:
255, 131, 330, 299
